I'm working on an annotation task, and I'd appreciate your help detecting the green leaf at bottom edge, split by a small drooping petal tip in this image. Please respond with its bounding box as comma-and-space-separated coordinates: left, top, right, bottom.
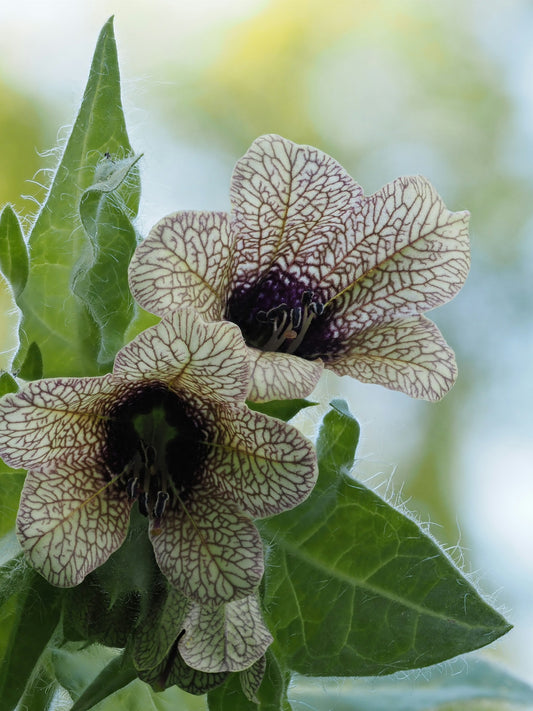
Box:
207, 650, 291, 711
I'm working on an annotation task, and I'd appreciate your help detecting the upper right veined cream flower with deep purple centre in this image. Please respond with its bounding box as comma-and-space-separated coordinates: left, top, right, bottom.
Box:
130, 135, 469, 401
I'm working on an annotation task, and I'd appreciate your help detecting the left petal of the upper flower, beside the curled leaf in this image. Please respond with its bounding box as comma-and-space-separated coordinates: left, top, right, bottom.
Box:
129, 212, 231, 321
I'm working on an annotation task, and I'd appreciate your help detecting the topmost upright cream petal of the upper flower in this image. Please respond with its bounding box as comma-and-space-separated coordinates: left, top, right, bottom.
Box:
231, 135, 362, 281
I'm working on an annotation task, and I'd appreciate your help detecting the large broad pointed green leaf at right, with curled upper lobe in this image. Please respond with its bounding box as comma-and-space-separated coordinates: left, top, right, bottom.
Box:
261, 401, 510, 676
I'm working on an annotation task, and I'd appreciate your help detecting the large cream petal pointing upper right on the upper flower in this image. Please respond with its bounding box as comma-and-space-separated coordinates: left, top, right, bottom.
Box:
328, 176, 470, 329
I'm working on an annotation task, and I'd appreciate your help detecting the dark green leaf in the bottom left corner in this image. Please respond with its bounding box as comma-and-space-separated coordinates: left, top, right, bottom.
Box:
0, 569, 62, 711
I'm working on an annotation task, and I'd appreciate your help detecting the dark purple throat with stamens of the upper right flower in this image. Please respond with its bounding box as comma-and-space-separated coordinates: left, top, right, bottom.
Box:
225, 270, 325, 359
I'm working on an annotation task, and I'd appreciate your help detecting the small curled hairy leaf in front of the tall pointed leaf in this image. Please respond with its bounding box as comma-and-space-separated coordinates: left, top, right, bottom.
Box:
73, 156, 140, 368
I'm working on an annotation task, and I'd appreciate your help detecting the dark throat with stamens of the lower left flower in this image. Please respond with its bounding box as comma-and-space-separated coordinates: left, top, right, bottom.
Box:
106, 383, 206, 533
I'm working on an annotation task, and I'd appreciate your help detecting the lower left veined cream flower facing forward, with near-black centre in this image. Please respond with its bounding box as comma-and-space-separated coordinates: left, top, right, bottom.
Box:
0, 309, 316, 605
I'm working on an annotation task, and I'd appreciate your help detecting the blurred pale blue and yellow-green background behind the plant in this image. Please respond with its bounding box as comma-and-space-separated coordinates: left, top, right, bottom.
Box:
0, 0, 533, 683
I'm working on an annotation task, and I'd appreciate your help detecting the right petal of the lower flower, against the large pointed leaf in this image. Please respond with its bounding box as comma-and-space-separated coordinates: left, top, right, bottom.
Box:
208, 406, 318, 518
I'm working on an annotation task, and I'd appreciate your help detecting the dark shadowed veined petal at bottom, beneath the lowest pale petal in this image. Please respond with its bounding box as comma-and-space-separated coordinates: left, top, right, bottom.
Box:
139, 642, 229, 696
